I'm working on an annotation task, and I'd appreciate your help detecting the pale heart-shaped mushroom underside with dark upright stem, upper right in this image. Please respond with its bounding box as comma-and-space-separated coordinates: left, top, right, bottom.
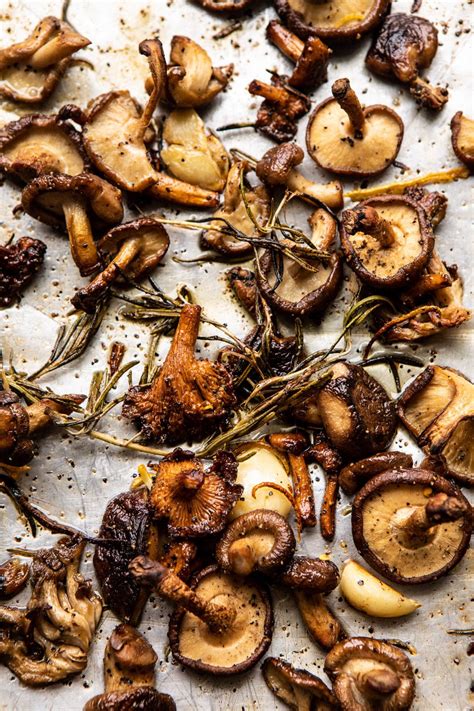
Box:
306, 79, 403, 178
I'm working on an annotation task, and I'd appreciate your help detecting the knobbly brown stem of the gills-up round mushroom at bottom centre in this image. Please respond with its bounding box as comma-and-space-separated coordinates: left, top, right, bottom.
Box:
129, 556, 236, 634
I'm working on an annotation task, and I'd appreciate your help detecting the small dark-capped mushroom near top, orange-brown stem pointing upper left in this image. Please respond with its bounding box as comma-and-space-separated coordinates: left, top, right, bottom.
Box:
266, 20, 332, 91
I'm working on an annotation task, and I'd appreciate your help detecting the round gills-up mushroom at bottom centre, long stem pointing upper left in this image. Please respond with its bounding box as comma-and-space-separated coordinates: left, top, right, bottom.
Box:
131, 557, 273, 676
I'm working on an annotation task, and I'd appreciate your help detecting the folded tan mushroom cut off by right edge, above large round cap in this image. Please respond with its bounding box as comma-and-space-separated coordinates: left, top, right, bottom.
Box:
398, 365, 474, 486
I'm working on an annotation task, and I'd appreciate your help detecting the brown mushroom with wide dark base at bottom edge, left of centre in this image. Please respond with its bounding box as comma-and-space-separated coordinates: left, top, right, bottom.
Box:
84, 624, 176, 711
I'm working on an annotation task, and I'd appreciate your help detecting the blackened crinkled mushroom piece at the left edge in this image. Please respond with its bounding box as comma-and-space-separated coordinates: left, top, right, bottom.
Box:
0, 237, 46, 307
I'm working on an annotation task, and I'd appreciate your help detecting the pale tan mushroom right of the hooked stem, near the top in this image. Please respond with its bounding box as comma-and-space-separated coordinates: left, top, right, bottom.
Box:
167, 35, 234, 108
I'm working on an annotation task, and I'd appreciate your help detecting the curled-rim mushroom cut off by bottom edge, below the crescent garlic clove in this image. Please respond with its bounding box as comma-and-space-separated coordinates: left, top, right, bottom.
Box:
324, 637, 415, 711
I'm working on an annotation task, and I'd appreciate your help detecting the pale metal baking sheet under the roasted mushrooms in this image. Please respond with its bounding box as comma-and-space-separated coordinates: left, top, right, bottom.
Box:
0, 0, 474, 711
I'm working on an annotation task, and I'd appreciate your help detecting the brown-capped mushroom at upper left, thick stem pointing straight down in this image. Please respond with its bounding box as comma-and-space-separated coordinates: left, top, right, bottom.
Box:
21, 173, 123, 276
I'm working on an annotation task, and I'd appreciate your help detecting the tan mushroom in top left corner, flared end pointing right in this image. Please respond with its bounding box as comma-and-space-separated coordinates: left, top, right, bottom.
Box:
0, 16, 90, 104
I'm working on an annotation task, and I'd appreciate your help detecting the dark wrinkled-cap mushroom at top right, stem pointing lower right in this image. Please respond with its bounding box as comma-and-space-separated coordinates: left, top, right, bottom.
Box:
365, 12, 448, 111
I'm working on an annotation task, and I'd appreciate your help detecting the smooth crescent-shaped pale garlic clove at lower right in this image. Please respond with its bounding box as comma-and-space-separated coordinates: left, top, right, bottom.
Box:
339, 560, 420, 617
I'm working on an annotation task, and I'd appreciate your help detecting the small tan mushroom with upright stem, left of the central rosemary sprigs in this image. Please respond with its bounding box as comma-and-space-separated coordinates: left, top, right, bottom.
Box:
201, 161, 270, 256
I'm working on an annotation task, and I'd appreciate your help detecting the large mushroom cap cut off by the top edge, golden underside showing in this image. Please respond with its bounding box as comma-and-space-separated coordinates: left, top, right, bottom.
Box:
273, 0, 390, 44
